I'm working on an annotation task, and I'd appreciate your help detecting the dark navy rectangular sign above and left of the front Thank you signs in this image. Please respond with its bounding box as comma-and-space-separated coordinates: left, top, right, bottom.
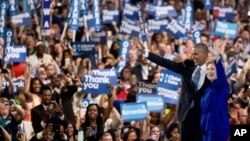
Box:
73, 42, 95, 56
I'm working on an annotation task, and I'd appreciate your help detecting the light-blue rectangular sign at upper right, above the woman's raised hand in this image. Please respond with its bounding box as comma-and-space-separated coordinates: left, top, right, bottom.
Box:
214, 21, 238, 39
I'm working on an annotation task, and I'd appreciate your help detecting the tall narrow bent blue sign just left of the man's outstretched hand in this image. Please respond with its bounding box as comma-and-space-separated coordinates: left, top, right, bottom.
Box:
116, 39, 130, 76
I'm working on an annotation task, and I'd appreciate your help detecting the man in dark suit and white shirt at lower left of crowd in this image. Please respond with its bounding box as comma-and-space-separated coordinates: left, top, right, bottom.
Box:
31, 86, 66, 134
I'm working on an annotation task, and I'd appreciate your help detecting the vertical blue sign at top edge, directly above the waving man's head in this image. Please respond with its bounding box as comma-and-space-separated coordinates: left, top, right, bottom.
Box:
184, 0, 194, 31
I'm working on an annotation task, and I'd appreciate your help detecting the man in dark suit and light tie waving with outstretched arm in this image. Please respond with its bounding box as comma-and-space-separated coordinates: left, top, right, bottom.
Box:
142, 43, 209, 141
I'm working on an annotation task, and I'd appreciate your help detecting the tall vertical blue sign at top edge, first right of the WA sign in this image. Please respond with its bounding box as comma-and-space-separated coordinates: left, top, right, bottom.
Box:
69, 0, 80, 30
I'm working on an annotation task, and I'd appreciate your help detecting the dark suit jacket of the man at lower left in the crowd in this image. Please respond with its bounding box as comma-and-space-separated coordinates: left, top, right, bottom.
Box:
31, 104, 66, 134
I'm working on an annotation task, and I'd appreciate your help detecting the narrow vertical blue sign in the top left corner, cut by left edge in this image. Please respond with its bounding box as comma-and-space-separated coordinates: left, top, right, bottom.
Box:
0, 1, 7, 37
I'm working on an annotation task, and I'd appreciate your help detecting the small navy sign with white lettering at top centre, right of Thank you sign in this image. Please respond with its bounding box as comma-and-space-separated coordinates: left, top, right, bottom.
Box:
123, 3, 139, 20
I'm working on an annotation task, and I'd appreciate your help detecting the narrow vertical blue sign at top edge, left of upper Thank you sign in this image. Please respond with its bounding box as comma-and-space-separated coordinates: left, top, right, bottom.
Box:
93, 0, 102, 31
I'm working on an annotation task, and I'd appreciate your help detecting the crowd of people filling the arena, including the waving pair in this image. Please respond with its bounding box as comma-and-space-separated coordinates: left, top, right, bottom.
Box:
0, 0, 250, 141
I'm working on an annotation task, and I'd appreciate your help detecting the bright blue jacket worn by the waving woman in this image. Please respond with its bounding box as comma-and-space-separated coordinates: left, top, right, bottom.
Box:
201, 60, 229, 132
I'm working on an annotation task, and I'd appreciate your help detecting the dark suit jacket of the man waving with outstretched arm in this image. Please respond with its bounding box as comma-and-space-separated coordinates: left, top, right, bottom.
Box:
148, 53, 209, 122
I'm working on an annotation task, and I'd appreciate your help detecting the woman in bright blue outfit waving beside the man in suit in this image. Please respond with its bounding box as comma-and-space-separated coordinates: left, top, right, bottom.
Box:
201, 41, 229, 141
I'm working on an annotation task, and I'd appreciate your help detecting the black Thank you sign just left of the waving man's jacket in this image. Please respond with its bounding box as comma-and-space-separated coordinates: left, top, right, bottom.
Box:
137, 81, 157, 94
